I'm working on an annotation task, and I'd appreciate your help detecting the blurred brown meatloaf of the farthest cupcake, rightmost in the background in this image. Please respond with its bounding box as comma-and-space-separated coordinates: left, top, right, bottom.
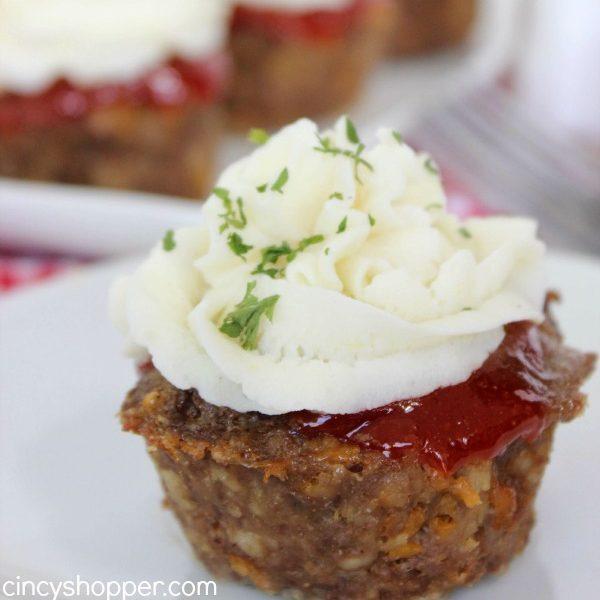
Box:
392, 0, 478, 56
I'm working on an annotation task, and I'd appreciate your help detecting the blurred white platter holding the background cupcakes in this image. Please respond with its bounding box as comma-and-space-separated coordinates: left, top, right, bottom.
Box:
0, 0, 522, 256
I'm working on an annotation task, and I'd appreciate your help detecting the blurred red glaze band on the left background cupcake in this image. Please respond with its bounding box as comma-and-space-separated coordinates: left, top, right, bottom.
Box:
0, 54, 229, 132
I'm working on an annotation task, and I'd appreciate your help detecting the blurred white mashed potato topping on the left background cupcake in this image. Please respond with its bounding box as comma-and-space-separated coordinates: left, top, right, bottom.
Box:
0, 0, 230, 93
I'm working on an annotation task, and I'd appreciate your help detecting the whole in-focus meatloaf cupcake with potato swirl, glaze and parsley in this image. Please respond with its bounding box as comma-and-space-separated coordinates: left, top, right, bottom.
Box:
112, 118, 594, 600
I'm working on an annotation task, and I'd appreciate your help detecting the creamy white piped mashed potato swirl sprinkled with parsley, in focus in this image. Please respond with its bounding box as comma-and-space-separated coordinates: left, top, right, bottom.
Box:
111, 118, 544, 414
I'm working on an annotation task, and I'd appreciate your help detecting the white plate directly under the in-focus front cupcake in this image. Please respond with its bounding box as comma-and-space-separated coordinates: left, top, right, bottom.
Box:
0, 250, 600, 600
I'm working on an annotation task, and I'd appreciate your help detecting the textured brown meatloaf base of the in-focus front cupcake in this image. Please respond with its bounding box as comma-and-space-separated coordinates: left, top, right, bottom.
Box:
121, 314, 594, 600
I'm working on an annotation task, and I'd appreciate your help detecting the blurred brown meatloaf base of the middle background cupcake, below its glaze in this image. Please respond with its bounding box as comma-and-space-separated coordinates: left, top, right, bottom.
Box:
228, 3, 393, 130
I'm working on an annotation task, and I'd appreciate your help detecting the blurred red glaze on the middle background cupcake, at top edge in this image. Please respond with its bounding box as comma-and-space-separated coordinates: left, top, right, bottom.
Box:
231, 0, 389, 40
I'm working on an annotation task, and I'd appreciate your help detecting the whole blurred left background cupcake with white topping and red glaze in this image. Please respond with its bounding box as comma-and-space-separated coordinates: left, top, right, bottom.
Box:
0, 0, 229, 197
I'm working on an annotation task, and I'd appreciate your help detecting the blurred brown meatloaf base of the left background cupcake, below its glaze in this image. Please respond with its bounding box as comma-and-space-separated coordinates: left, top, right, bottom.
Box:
0, 106, 222, 198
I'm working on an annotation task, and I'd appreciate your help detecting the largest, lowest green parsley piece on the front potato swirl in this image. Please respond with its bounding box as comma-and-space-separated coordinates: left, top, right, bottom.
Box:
219, 281, 279, 350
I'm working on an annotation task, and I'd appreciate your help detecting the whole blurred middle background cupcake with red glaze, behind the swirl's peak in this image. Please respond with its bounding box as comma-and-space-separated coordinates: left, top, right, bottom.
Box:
229, 0, 392, 128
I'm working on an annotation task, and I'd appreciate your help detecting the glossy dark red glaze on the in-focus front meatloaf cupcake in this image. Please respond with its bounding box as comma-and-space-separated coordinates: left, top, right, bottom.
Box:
293, 322, 553, 473
